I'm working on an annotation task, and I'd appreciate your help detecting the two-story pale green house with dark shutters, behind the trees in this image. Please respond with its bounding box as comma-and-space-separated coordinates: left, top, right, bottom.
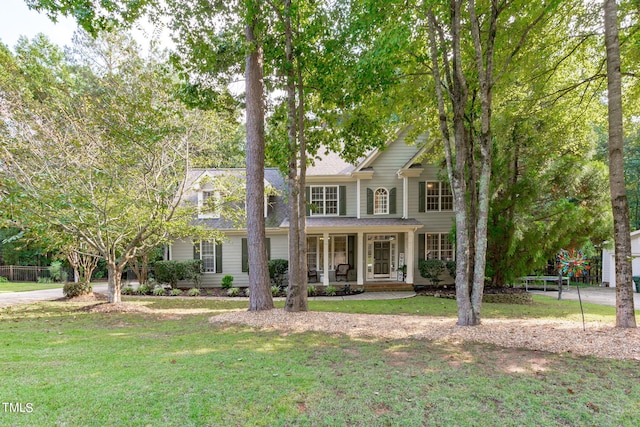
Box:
169, 132, 454, 288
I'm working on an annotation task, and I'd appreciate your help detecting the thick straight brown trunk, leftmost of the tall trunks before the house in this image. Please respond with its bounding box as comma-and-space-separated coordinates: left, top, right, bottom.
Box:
245, 1, 273, 311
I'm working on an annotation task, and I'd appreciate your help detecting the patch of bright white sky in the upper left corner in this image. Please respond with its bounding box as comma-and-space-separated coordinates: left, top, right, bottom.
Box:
0, 0, 77, 50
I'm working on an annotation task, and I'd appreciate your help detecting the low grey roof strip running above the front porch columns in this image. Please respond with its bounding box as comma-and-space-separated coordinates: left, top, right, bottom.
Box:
280, 216, 424, 233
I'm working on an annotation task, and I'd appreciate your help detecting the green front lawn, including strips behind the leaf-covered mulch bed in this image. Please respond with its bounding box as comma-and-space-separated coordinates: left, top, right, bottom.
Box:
0, 297, 640, 426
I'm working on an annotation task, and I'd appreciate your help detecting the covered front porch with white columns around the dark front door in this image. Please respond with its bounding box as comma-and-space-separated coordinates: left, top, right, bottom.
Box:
307, 217, 422, 291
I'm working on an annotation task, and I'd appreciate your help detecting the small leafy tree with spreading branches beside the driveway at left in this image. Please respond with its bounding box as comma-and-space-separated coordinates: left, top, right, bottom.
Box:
0, 31, 218, 303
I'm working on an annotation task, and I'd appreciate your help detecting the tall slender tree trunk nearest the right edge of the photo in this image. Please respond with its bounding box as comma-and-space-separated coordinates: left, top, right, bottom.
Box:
604, 0, 636, 328
